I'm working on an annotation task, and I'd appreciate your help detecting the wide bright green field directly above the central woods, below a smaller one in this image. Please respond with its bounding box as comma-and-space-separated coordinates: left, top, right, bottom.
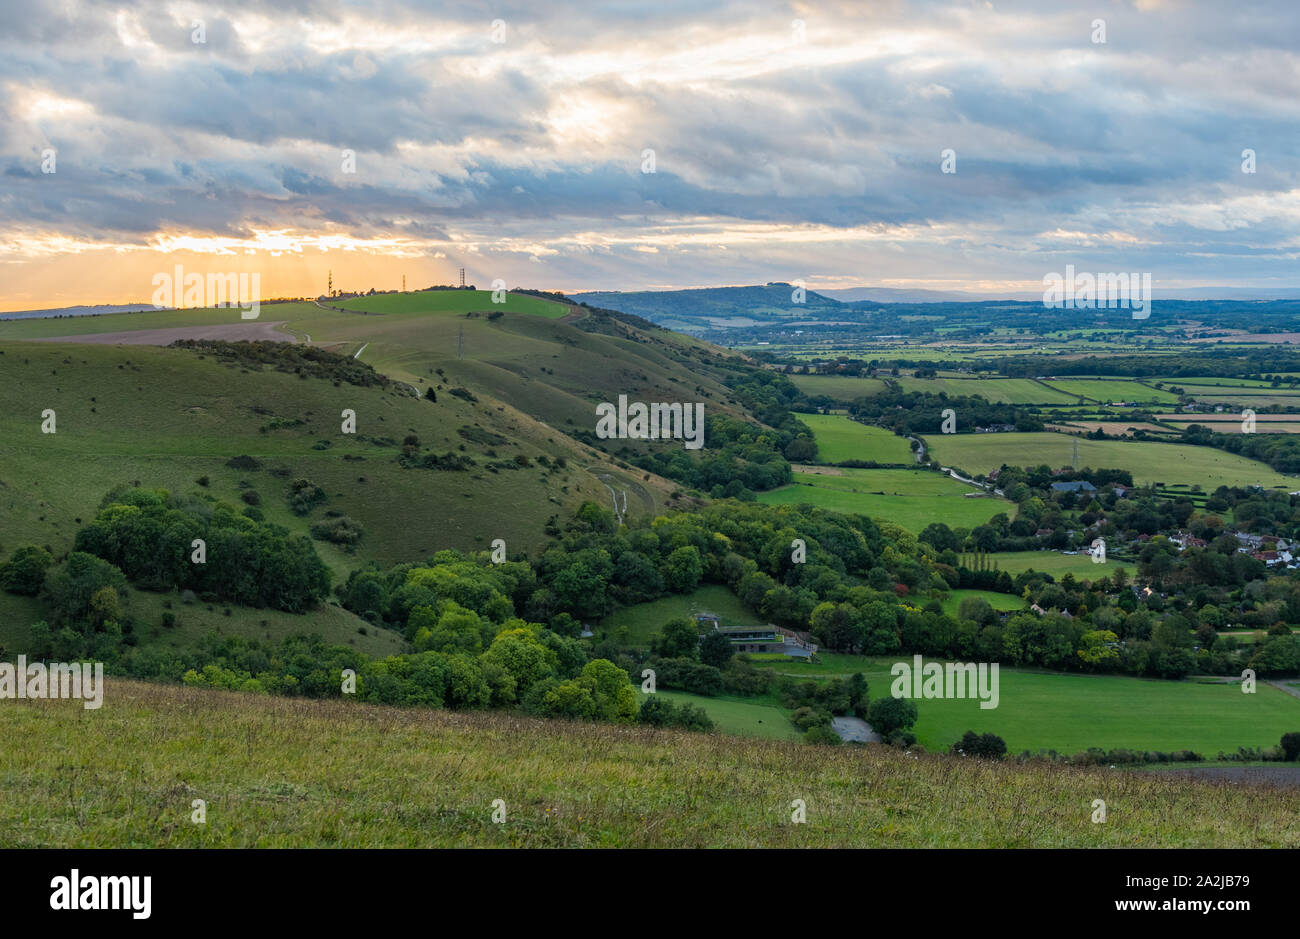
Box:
758, 468, 1015, 532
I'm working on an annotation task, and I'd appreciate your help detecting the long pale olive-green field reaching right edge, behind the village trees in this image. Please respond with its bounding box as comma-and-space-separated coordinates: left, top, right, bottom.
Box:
927, 432, 1297, 490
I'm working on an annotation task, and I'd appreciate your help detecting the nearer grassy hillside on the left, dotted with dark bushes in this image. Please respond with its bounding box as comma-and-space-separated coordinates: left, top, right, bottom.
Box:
0, 343, 647, 571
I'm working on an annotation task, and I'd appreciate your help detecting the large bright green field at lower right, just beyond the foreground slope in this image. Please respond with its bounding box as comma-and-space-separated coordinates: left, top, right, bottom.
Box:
755, 654, 1300, 758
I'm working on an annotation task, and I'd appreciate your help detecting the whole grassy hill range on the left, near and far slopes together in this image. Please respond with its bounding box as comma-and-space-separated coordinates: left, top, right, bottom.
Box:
0, 290, 764, 572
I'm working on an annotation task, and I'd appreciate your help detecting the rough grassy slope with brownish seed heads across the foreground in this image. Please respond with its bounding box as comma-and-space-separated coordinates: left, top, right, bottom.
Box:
0, 680, 1300, 847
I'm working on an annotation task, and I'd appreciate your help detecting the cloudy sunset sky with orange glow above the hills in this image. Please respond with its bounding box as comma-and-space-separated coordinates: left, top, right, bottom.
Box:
0, 0, 1300, 311
